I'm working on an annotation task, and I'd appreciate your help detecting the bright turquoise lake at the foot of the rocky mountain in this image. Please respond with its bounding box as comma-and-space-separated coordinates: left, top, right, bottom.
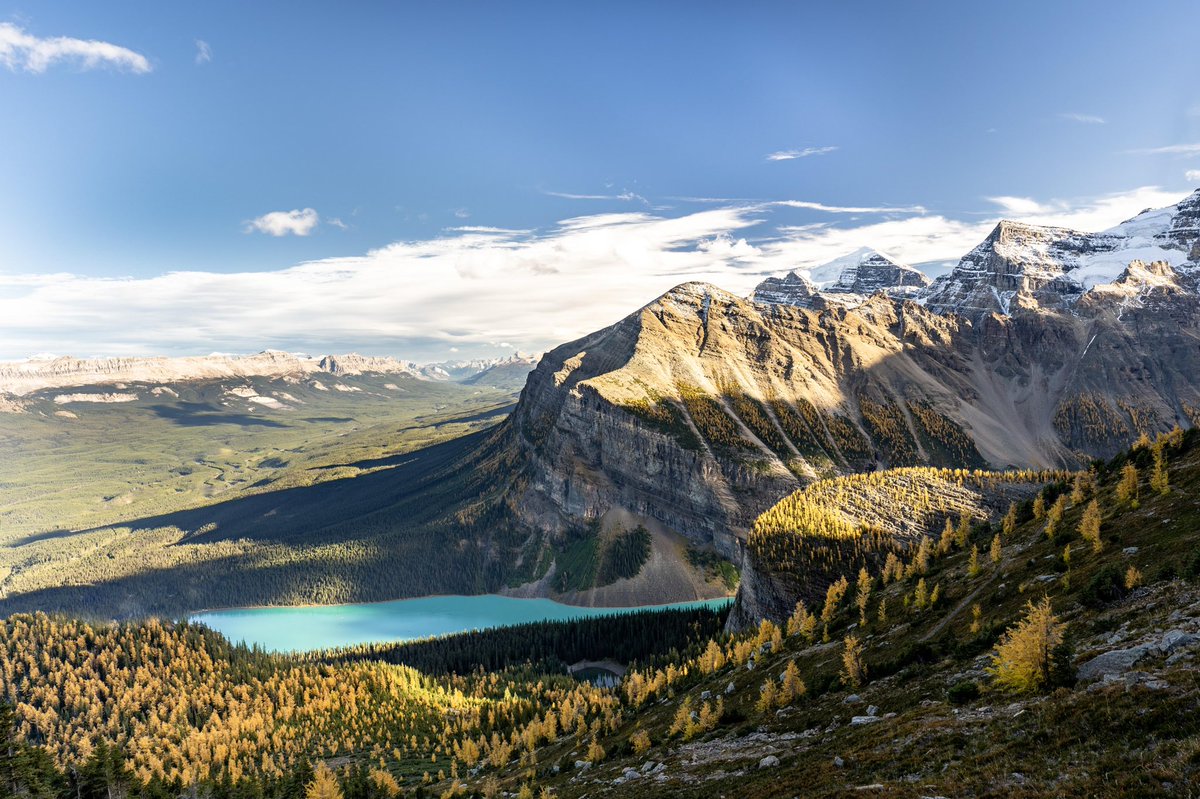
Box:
191, 595, 732, 651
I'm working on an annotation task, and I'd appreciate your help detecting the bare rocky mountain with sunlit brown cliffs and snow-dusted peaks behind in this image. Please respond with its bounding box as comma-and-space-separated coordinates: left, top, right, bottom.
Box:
489, 193, 1200, 606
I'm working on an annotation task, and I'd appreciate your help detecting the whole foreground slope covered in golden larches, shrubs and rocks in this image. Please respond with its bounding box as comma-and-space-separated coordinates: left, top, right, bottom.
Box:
2, 431, 1200, 799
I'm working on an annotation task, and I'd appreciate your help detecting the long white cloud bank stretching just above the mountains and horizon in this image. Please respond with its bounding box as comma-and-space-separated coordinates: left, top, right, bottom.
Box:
0, 187, 1182, 359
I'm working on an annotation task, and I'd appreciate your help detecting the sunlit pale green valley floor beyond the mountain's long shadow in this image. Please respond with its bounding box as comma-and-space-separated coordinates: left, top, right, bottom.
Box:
0, 374, 514, 535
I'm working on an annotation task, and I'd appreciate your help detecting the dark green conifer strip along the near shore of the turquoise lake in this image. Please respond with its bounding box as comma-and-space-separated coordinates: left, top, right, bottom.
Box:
308, 607, 728, 674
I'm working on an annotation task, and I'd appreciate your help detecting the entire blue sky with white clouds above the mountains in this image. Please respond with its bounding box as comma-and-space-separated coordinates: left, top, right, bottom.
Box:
0, 0, 1200, 360
